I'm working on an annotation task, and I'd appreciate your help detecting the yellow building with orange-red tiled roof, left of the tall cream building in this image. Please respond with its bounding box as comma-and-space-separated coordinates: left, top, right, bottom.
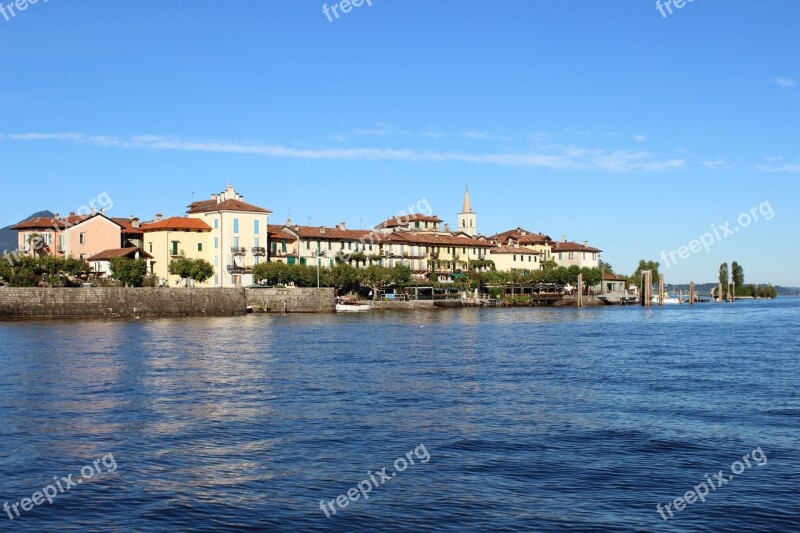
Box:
140, 216, 213, 287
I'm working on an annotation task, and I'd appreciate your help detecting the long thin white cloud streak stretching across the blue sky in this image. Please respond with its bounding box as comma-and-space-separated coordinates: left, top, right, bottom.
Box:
1, 132, 686, 172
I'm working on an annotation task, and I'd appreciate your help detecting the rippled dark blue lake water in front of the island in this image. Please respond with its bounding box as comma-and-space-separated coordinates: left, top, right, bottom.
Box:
0, 298, 800, 532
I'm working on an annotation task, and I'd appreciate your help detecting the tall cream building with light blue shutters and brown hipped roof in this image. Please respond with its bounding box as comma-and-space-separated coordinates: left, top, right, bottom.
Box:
188, 184, 272, 287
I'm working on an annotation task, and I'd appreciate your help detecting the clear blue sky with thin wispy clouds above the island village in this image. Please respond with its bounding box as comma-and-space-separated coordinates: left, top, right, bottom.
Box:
0, 0, 800, 285
